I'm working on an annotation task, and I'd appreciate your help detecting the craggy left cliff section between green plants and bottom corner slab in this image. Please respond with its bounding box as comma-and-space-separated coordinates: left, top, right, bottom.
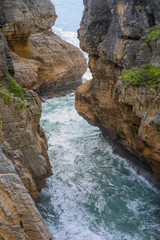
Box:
0, 91, 52, 200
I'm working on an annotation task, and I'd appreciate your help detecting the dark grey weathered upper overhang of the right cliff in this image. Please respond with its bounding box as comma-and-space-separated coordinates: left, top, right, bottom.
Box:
79, 0, 160, 68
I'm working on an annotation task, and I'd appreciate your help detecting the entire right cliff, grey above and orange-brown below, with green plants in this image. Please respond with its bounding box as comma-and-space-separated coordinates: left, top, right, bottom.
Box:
76, 0, 160, 179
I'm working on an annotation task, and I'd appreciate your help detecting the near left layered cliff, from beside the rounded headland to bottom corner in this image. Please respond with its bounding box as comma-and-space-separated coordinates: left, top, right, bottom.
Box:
0, 33, 52, 240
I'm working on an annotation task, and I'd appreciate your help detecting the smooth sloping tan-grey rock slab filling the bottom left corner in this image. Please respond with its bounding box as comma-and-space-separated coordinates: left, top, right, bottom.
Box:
0, 149, 52, 240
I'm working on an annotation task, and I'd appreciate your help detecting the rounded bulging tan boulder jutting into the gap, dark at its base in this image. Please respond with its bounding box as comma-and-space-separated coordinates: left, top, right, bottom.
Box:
29, 32, 87, 96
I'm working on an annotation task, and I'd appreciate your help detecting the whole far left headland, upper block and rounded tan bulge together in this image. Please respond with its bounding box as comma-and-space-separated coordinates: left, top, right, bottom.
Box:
0, 0, 87, 97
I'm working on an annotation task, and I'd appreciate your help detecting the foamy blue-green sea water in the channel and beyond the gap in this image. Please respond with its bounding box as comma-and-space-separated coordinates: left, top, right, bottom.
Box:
37, 0, 160, 240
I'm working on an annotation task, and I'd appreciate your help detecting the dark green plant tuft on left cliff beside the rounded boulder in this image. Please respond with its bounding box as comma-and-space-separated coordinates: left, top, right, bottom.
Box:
7, 75, 25, 100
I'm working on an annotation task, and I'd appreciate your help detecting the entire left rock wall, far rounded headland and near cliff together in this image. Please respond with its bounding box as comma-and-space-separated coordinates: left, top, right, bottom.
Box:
0, 0, 86, 240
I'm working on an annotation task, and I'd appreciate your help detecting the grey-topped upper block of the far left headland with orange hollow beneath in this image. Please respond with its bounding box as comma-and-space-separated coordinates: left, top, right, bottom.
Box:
2, 0, 57, 51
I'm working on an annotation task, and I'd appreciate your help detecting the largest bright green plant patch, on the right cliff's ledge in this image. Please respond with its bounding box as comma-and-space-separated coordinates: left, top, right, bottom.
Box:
121, 64, 160, 92
